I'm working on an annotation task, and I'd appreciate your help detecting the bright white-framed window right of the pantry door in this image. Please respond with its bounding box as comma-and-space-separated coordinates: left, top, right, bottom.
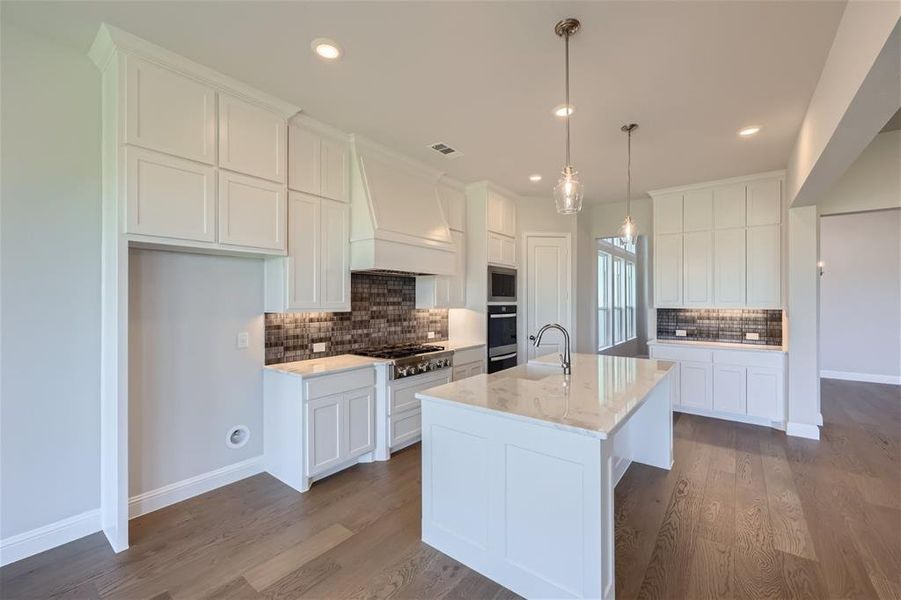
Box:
598, 238, 638, 351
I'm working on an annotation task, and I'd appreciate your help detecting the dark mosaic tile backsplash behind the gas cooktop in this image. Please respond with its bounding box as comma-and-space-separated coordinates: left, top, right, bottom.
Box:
265, 273, 447, 365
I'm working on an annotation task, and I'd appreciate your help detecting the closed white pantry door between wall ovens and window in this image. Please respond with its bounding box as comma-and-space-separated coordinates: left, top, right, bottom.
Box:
525, 235, 572, 359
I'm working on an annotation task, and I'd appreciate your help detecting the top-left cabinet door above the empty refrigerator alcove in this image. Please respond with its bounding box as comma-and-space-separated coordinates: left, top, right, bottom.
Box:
125, 56, 216, 165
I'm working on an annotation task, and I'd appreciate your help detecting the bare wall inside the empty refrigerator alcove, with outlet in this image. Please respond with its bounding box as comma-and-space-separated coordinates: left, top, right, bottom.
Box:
128, 249, 264, 497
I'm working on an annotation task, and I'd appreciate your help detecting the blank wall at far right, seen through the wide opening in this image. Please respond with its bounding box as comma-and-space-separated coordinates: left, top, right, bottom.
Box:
820, 209, 901, 383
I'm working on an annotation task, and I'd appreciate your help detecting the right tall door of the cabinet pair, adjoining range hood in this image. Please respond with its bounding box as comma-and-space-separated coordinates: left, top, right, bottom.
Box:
320, 200, 350, 311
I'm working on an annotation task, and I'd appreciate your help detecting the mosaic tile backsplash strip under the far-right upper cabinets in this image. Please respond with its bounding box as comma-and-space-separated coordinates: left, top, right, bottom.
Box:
657, 308, 782, 346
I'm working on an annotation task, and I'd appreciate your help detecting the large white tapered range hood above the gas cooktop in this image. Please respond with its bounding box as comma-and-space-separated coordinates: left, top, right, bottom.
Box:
350, 136, 454, 275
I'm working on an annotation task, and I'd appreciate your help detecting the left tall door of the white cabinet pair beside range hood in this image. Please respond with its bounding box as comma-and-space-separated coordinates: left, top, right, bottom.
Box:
287, 192, 322, 310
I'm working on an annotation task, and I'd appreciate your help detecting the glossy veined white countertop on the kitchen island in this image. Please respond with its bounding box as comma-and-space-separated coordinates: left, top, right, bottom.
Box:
416, 354, 674, 439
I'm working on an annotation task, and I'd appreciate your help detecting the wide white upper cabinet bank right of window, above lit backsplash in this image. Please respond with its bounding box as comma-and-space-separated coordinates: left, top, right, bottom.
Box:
651, 173, 783, 308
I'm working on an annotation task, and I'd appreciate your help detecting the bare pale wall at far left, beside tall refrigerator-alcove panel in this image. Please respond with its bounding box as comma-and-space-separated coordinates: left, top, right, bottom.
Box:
0, 19, 100, 538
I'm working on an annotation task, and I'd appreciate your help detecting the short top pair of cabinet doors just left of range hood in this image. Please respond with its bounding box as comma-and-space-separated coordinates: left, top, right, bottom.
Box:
288, 120, 350, 202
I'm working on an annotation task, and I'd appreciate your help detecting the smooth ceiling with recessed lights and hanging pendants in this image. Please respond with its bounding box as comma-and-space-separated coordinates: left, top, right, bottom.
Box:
2, 0, 844, 202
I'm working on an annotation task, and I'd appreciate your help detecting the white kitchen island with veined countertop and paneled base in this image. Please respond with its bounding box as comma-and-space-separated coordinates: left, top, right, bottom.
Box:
417, 354, 673, 599
